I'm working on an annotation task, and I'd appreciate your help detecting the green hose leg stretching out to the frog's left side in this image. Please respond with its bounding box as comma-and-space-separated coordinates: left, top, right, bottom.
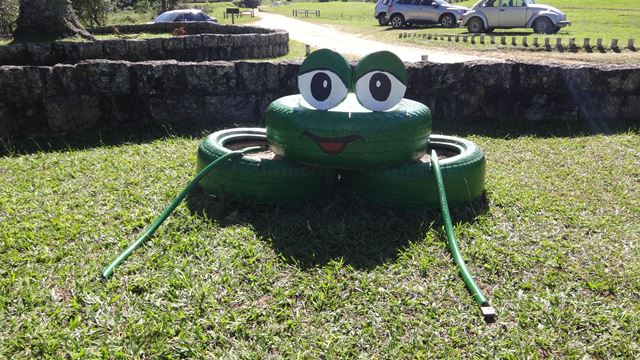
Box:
102, 146, 262, 279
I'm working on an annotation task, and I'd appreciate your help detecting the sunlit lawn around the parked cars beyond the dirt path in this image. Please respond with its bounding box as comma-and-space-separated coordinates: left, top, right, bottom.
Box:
263, 0, 640, 50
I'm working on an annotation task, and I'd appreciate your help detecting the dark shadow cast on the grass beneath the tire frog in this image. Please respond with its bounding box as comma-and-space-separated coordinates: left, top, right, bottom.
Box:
187, 187, 489, 269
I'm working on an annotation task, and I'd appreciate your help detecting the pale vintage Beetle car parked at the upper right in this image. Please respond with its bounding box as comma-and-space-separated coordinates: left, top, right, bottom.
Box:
462, 0, 571, 34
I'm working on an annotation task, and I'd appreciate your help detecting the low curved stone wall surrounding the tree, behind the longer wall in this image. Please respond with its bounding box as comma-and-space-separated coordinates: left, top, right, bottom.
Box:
0, 23, 289, 65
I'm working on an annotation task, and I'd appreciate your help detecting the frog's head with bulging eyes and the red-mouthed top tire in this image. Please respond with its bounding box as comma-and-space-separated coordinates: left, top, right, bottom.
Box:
267, 49, 431, 168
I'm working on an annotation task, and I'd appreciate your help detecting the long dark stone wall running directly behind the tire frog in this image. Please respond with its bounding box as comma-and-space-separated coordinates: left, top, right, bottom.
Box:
0, 60, 640, 137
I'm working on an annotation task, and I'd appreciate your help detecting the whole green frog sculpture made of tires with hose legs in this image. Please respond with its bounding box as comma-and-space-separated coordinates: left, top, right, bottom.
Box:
103, 49, 495, 321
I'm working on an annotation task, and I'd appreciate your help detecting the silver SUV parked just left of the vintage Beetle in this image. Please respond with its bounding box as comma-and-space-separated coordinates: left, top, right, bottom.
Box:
387, 0, 468, 29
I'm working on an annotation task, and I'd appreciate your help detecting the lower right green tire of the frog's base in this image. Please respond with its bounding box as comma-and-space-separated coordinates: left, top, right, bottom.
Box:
342, 135, 486, 209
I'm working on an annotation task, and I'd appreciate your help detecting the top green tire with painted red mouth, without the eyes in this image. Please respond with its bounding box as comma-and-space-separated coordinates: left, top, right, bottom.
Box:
266, 93, 431, 169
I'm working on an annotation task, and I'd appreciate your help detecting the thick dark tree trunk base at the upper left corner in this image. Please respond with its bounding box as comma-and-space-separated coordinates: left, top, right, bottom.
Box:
13, 0, 95, 42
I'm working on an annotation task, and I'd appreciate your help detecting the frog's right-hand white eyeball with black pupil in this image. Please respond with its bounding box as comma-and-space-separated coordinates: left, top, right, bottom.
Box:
355, 71, 407, 111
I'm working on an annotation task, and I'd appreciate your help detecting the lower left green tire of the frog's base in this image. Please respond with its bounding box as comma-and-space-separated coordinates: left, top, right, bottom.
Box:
197, 128, 337, 203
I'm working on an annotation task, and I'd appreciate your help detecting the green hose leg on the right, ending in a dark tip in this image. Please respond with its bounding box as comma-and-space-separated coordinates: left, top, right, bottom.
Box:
431, 150, 497, 322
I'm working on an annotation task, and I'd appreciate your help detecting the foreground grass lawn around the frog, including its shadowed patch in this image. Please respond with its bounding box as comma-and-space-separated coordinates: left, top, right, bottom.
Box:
0, 124, 640, 359
